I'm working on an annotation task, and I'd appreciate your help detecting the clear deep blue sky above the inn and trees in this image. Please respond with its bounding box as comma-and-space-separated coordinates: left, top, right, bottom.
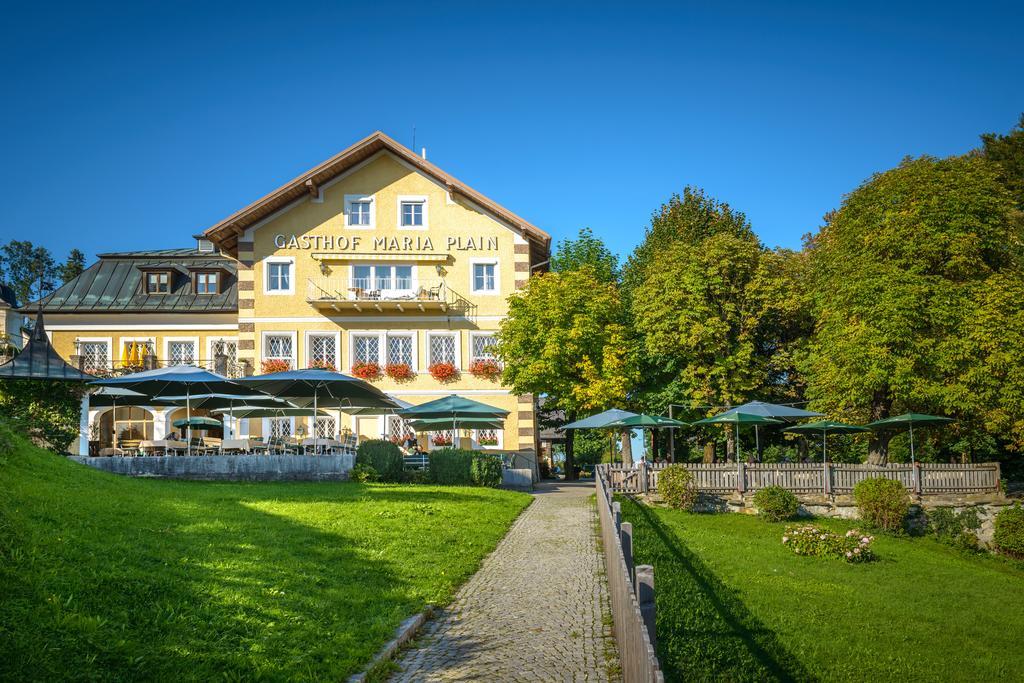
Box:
0, 2, 1024, 260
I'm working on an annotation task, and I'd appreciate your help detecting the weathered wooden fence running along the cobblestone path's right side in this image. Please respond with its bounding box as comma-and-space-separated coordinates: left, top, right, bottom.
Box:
595, 467, 665, 683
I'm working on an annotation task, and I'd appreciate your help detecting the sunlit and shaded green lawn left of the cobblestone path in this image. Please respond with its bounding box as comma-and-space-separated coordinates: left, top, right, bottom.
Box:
0, 436, 529, 680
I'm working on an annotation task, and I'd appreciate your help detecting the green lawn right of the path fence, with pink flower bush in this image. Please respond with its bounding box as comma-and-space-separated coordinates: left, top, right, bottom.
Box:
623, 501, 1024, 681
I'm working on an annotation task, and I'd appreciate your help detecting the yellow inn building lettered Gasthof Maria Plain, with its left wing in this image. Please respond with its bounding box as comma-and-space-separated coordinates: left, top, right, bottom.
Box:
37, 132, 551, 465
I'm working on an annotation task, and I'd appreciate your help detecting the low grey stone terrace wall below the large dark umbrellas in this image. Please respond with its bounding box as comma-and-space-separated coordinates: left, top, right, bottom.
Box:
71, 454, 355, 481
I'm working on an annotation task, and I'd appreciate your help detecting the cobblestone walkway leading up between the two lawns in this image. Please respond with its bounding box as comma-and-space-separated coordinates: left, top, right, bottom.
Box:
392, 484, 616, 681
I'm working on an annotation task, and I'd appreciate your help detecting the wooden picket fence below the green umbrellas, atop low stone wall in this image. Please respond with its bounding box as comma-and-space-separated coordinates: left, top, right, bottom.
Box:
598, 463, 1000, 496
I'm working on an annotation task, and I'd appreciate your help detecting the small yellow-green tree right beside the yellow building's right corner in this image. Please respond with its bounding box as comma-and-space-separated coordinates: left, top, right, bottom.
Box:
496, 267, 634, 477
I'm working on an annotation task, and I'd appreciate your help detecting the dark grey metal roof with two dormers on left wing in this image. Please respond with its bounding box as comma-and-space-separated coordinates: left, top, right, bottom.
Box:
22, 249, 239, 313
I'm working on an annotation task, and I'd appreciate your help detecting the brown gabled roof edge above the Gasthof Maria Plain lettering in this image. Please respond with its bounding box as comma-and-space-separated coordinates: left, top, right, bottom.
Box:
203, 131, 551, 260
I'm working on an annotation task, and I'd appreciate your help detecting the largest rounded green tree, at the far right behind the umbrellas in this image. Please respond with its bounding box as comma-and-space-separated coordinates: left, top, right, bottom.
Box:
804, 157, 1024, 463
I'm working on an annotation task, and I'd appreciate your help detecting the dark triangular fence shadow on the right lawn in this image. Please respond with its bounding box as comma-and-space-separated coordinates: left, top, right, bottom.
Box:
623, 501, 814, 681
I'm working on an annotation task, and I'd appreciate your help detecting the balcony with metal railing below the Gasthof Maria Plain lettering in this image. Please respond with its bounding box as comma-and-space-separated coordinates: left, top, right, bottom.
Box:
306, 276, 473, 314
